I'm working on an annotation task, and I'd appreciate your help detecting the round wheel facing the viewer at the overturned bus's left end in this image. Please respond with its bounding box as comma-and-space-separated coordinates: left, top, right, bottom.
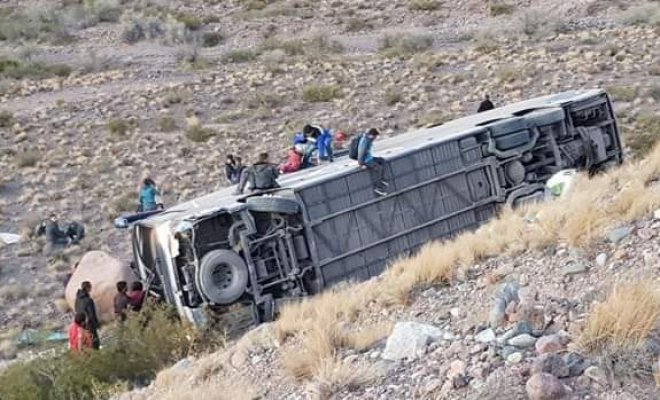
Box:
199, 250, 248, 305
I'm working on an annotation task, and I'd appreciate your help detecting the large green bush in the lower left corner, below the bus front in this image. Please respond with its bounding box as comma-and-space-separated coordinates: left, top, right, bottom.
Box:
0, 307, 194, 400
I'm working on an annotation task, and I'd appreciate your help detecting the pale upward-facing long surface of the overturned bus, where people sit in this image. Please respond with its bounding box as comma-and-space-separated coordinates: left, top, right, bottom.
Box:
140, 89, 604, 225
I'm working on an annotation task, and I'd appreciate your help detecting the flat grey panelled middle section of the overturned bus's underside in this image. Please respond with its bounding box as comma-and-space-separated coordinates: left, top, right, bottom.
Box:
299, 138, 498, 285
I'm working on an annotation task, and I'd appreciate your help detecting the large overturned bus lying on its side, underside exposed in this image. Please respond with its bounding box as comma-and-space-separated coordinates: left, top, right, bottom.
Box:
132, 90, 622, 324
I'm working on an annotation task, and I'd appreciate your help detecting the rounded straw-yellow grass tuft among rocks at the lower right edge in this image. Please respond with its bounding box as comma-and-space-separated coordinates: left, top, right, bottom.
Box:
579, 280, 660, 354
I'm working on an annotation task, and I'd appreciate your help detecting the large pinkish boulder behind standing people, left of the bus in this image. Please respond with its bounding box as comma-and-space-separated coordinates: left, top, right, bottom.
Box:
65, 251, 137, 322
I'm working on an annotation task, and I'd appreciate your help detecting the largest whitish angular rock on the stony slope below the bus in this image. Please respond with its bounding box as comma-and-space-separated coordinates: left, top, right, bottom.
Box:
382, 322, 444, 361
